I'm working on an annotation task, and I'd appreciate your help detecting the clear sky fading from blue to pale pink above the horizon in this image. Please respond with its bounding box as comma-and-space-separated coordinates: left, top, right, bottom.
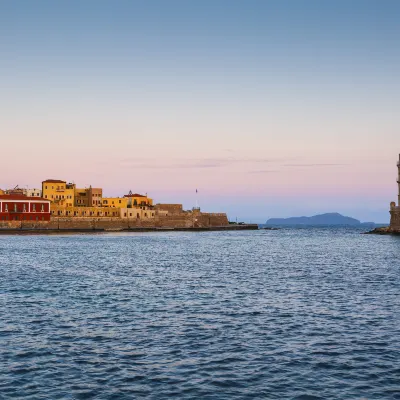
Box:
0, 0, 400, 222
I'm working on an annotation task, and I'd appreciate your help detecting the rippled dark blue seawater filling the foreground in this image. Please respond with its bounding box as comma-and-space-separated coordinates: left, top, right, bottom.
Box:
0, 228, 400, 399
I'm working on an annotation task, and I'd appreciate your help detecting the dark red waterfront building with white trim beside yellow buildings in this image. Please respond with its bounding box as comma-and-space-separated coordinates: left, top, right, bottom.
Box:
0, 195, 50, 221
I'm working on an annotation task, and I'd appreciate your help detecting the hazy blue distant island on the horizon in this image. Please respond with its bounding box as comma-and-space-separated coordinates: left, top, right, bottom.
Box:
265, 213, 375, 226
